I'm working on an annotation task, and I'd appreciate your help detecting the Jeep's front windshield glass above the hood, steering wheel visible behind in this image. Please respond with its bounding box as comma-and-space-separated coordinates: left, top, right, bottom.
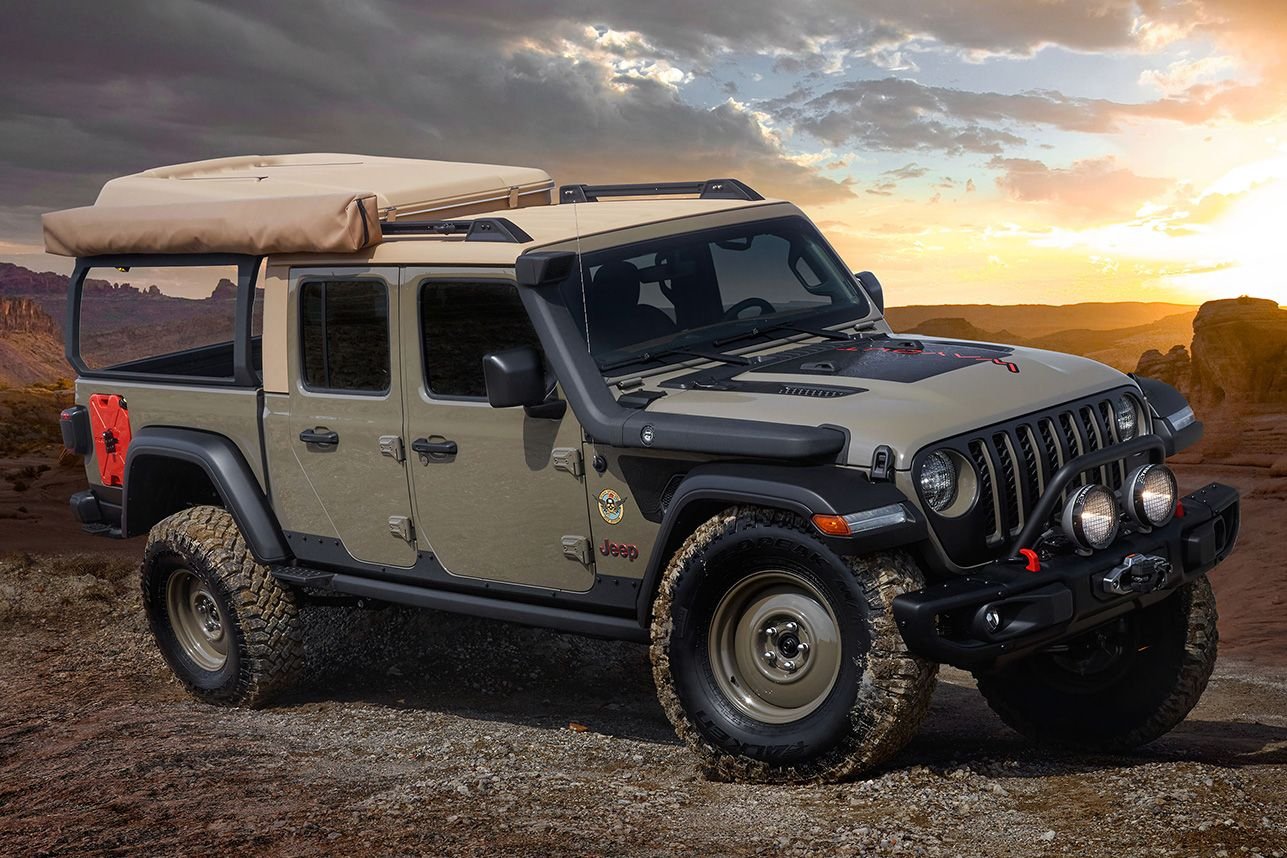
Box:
562, 217, 869, 369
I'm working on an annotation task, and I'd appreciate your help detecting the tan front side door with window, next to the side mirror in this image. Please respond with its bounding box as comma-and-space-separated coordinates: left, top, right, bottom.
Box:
400, 269, 595, 592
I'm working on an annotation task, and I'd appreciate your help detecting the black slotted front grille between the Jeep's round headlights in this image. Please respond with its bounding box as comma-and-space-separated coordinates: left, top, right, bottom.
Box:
965, 395, 1144, 547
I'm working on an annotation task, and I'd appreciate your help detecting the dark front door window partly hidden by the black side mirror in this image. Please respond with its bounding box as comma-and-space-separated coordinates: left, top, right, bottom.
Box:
420, 280, 541, 399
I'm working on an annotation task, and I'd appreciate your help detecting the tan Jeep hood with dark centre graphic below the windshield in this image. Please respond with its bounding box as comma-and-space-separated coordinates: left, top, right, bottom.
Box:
647, 337, 1134, 470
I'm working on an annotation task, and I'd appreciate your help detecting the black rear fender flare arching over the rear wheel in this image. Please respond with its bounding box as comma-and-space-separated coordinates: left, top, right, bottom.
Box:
121, 426, 291, 563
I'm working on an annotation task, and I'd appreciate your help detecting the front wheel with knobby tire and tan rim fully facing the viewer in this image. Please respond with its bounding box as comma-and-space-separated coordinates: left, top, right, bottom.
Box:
651, 507, 938, 783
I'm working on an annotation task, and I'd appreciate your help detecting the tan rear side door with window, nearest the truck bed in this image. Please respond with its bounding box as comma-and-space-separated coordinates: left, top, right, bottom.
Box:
288, 268, 416, 566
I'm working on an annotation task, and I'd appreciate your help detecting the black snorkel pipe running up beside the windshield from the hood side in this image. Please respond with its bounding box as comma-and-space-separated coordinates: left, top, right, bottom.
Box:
517, 262, 848, 461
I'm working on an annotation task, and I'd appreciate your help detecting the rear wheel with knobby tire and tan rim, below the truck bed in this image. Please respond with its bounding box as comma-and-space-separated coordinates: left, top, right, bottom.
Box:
140, 507, 304, 707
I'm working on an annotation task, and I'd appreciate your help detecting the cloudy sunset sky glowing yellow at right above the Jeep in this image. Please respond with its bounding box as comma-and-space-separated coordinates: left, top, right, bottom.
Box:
0, 0, 1287, 305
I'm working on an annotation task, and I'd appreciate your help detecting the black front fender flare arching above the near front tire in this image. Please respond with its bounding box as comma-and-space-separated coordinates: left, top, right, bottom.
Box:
637, 462, 928, 628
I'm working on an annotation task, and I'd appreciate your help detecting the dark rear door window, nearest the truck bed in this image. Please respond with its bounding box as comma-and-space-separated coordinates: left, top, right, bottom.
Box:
300, 279, 389, 394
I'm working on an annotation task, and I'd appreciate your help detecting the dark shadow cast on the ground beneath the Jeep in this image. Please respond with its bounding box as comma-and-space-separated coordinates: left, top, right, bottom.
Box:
284, 607, 1287, 777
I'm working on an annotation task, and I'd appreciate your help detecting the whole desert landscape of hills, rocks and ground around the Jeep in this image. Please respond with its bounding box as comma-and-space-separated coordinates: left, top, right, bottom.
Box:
0, 265, 1287, 855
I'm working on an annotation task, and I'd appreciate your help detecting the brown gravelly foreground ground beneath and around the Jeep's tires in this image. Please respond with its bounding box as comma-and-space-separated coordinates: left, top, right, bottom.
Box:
0, 554, 1287, 855
